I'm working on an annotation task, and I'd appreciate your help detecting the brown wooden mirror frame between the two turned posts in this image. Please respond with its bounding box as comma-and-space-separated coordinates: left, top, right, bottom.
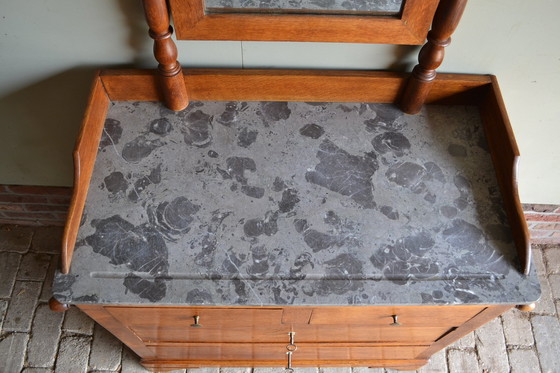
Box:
168, 0, 439, 45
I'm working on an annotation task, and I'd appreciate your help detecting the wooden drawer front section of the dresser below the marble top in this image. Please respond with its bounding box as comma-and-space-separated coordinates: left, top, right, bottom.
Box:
80, 306, 507, 370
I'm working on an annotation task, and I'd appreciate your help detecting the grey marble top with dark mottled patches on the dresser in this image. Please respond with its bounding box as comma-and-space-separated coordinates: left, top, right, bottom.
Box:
54, 102, 540, 306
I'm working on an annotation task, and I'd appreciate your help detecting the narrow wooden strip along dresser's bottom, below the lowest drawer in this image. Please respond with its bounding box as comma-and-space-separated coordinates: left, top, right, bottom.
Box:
140, 359, 428, 370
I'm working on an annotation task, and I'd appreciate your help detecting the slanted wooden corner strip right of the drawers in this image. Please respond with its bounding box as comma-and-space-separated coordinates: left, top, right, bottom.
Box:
417, 305, 513, 359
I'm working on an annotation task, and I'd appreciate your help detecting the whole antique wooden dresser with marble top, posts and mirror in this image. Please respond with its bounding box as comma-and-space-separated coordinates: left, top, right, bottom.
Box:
51, 0, 540, 370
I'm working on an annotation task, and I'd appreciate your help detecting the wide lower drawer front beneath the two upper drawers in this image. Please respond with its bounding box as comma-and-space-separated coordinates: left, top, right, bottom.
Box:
149, 343, 428, 360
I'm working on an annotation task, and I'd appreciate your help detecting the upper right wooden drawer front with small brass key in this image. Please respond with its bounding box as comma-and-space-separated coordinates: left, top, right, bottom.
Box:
310, 306, 484, 327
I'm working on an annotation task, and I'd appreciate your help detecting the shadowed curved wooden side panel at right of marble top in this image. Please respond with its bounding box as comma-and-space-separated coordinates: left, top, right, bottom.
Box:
481, 76, 531, 275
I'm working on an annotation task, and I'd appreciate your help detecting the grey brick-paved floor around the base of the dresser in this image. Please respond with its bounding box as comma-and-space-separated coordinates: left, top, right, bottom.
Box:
0, 226, 560, 373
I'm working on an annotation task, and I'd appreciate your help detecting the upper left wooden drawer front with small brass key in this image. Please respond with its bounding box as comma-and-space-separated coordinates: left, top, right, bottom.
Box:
106, 307, 289, 342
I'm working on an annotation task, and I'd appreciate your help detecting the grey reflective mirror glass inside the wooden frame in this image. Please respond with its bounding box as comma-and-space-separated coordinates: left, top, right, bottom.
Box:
205, 0, 405, 16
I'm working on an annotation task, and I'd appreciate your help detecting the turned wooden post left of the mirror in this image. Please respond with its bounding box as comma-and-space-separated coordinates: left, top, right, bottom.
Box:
142, 0, 189, 111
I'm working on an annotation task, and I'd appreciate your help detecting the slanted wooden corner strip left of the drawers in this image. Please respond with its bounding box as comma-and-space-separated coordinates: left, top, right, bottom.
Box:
76, 304, 155, 359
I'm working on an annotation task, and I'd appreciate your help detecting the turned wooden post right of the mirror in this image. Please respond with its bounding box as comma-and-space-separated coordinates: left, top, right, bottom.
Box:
400, 0, 467, 114
